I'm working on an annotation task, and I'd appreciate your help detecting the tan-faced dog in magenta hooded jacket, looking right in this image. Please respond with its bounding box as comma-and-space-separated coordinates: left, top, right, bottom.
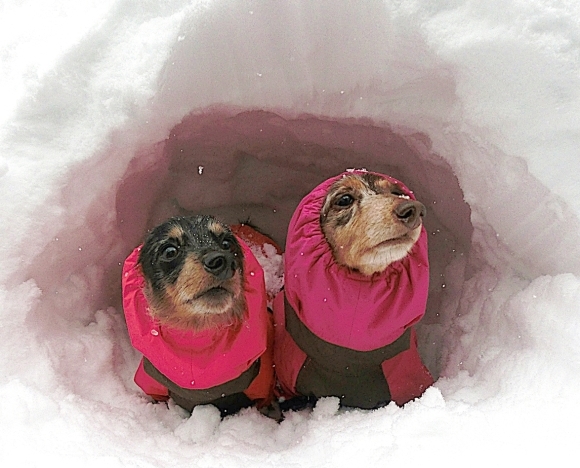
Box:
274, 171, 433, 408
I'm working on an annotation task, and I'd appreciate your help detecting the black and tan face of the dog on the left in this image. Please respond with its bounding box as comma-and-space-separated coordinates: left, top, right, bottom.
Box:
139, 216, 246, 330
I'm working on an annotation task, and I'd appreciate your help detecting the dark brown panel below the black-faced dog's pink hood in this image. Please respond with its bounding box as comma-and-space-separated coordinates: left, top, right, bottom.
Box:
143, 358, 260, 415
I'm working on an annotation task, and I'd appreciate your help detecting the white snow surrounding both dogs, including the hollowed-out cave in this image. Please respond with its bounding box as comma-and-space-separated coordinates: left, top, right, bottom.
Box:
0, 0, 580, 467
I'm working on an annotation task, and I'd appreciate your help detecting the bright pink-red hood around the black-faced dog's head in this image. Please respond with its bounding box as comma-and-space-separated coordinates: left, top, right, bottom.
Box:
122, 239, 270, 395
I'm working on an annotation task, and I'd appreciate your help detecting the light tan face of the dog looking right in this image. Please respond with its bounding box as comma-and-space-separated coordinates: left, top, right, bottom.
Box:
320, 173, 426, 275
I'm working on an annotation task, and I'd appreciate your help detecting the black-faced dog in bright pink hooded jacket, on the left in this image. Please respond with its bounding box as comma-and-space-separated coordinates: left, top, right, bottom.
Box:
123, 216, 273, 415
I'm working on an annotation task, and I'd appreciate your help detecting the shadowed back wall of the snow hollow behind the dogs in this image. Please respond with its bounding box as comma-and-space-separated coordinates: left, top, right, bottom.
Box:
116, 110, 473, 376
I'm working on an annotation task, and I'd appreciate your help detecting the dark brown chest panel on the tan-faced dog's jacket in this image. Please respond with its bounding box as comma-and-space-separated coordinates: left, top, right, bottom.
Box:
285, 301, 411, 409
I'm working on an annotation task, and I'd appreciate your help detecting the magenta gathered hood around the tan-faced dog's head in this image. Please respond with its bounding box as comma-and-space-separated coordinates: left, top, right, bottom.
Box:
285, 171, 429, 351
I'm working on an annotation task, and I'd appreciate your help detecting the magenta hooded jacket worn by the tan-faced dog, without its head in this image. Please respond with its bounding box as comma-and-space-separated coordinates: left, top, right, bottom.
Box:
274, 174, 433, 407
